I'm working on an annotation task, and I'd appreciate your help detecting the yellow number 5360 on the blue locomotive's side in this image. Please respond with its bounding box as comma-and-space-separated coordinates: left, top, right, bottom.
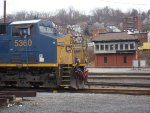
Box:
15, 39, 32, 46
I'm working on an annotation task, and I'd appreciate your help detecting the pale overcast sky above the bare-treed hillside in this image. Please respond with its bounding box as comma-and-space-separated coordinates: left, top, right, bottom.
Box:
0, 0, 150, 16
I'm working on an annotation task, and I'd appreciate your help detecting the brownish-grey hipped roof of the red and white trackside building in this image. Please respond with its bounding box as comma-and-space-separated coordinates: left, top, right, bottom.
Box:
92, 32, 138, 42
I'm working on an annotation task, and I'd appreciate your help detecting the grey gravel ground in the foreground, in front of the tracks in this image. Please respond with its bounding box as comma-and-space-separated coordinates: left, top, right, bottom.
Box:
0, 93, 150, 113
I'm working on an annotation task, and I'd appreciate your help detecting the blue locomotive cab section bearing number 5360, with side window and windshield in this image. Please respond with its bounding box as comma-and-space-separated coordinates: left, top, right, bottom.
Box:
11, 20, 58, 66
